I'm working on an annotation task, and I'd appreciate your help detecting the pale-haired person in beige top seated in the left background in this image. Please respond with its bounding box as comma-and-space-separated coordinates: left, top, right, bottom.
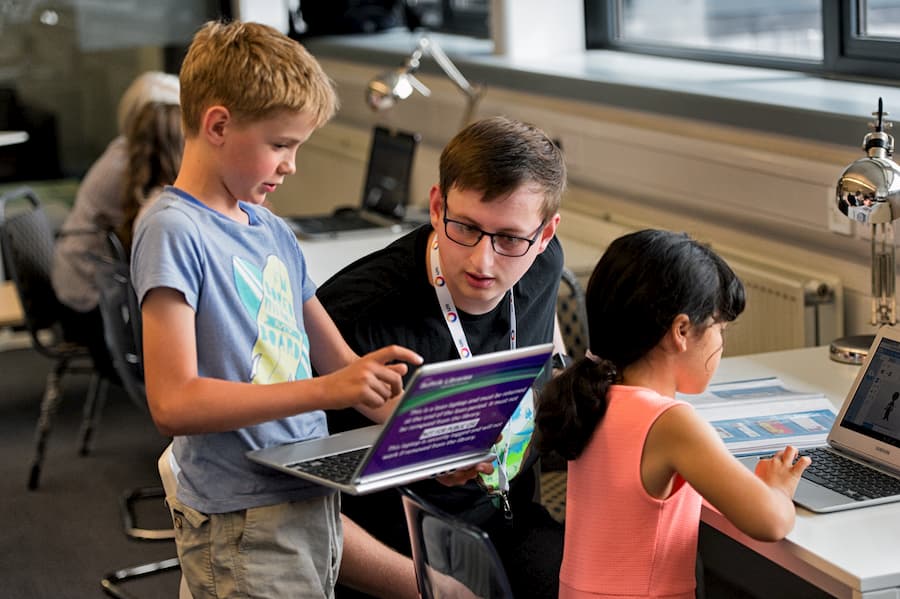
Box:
51, 71, 179, 372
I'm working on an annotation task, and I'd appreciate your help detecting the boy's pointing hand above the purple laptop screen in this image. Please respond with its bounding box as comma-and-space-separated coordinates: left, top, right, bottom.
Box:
321, 345, 422, 408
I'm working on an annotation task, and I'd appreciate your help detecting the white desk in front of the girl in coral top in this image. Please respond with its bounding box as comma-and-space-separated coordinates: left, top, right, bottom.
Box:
702, 347, 900, 599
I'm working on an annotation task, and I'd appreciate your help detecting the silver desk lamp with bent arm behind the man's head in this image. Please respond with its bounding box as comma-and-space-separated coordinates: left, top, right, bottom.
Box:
366, 36, 484, 127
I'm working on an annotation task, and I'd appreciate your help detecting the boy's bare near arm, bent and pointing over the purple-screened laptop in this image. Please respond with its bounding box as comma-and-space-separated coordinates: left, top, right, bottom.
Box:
141, 287, 421, 436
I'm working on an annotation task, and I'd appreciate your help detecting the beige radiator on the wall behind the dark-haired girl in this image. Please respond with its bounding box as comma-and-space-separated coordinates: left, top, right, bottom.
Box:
560, 214, 844, 356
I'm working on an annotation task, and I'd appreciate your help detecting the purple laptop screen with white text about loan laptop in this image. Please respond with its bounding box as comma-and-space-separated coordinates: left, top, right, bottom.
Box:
362, 346, 550, 476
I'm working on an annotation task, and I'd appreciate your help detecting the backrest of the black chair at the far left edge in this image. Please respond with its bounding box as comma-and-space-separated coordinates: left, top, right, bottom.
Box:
0, 187, 61, 351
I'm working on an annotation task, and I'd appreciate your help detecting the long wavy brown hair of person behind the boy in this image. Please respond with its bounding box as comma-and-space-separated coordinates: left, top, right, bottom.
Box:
116, 102, 184, 254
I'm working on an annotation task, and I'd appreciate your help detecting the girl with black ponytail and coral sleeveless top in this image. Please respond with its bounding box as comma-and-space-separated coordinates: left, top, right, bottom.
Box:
536, 230, 810, 599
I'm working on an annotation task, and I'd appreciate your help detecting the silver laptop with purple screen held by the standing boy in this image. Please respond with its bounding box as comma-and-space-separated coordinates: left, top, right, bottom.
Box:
247, 343, 553, 495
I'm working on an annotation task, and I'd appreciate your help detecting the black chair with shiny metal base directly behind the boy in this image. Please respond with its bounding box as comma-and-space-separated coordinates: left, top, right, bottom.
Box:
95, 231, 179, 599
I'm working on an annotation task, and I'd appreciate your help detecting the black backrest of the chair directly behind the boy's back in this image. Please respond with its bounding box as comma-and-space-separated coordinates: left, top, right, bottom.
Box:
95, 232, 146, 406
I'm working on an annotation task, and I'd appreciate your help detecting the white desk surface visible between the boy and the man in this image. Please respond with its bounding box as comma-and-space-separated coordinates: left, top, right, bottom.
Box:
297, 230, 409, 285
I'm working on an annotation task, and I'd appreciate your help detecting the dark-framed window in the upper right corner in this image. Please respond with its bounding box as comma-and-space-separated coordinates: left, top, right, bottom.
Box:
585, 0, 900, 78
